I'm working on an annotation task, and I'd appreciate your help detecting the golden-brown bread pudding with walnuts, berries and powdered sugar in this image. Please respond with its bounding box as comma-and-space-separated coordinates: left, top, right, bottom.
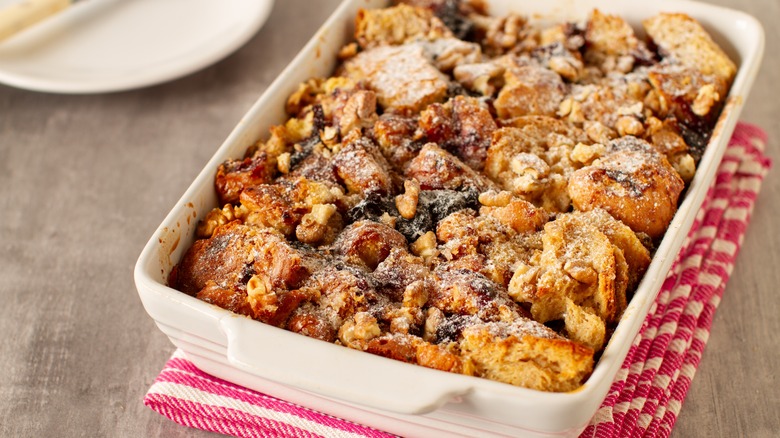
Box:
169, 0, 736, 391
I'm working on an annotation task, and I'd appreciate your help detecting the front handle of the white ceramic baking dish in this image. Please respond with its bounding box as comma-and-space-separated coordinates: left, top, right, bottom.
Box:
220, 314, 471, 414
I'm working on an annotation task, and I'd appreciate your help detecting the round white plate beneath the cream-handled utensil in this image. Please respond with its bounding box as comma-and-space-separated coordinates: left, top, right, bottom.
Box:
0, 0, 274, 93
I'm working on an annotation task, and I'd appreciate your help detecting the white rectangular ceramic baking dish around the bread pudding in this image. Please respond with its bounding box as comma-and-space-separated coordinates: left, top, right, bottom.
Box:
134, 0, 764, 437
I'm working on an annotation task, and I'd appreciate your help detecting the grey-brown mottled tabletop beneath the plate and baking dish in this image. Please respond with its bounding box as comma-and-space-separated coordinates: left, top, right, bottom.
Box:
0, 0, 780, 437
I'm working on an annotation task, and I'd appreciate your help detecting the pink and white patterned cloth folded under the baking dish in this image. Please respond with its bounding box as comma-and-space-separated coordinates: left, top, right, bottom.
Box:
144, 123, 771, 438
